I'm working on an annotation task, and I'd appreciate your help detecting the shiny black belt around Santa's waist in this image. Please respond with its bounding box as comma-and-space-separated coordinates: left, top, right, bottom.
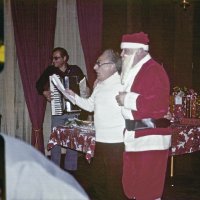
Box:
125, 118, 170, 131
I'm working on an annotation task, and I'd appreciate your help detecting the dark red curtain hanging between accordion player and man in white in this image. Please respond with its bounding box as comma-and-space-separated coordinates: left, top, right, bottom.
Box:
77, 0, 103, 86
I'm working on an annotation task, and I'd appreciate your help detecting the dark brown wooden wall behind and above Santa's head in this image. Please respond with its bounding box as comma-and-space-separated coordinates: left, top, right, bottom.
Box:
103, 0, 200, 91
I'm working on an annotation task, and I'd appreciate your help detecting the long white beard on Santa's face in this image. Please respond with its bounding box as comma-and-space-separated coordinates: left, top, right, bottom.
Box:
121, 52, 136, 85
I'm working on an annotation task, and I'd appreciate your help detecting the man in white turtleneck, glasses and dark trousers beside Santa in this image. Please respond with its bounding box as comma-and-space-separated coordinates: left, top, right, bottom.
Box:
68, 49, 125, 200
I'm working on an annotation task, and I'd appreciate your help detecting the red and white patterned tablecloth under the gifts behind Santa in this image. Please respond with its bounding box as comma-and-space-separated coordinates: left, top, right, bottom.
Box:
171, 124, 200, 156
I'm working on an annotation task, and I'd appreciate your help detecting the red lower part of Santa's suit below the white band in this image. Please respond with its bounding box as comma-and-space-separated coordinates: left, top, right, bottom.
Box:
122, 150, 169, 200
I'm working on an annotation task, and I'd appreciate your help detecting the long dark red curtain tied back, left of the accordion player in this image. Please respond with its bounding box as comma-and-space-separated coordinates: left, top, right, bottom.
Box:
11, 0, 57, 153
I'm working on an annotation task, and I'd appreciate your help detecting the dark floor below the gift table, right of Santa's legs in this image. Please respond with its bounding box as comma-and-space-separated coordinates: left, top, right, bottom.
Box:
163, 152, 200, 200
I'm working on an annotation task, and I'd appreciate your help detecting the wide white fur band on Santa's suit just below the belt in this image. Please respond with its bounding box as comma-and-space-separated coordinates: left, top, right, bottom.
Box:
124, 131, 171, 152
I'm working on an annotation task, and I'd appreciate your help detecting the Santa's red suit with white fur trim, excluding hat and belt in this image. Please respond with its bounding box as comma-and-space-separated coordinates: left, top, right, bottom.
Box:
122, 32, 171, 200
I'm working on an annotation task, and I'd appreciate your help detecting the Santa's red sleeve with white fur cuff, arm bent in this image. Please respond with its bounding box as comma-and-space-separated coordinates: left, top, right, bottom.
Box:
124, 64, 169, 113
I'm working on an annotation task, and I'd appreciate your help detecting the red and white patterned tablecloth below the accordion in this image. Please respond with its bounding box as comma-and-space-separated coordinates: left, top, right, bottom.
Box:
47, 126, 95, 162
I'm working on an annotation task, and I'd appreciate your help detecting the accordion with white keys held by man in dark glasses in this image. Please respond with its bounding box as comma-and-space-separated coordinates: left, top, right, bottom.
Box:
49, 75, 81, 115
